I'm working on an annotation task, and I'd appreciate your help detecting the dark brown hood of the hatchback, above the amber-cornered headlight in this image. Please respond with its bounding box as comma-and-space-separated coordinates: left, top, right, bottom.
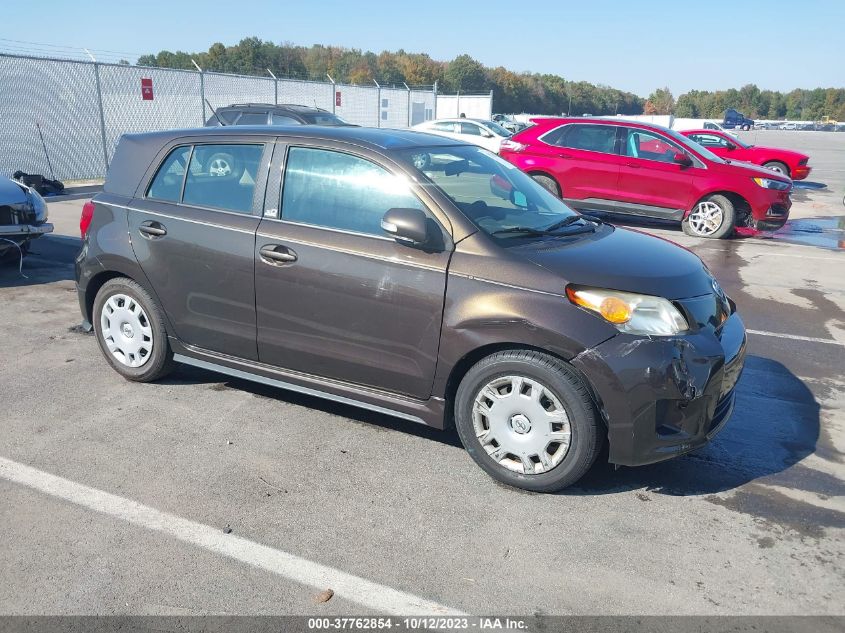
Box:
518, 225, 713, 299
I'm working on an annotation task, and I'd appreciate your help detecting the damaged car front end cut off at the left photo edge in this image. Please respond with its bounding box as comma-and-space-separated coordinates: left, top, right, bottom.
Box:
0, 177, 53, 263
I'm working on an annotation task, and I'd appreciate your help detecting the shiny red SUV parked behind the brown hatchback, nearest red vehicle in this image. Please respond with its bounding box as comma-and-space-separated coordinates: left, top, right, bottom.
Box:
500, 118, 792, 238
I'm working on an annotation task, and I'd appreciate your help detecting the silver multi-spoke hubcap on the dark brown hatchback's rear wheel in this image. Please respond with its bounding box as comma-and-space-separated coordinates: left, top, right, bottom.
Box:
100, 294, 153, 367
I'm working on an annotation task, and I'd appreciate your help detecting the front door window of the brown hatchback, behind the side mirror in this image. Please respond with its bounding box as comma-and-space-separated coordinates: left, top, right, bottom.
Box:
282, 147, 425, 237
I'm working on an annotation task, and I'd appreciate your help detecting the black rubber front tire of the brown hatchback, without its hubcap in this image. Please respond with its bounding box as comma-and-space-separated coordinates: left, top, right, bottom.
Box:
454, 350, 604, 492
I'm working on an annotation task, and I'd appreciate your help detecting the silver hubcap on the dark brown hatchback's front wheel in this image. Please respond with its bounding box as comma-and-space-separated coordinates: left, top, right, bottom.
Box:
472, 376, 572, 475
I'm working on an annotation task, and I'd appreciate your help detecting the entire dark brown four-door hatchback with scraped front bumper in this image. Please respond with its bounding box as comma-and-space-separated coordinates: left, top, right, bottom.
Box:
76, 127, 745, 491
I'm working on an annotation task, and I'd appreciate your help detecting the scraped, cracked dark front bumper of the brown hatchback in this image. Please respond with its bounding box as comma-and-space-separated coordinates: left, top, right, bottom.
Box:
572, 312, 746, 466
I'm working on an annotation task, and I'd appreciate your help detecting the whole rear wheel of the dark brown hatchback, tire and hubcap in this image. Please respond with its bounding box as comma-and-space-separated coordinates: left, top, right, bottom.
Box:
91, 277, 174, 382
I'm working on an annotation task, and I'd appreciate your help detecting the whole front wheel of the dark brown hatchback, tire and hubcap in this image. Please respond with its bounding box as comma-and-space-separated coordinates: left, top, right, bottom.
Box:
455, 350, 603, 492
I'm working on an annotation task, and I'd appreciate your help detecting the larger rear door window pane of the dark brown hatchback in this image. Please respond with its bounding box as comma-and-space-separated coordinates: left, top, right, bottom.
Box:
182, 144, 264, 214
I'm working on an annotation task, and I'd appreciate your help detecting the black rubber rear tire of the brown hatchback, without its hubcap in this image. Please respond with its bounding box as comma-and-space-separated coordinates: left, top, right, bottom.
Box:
91, 277, 175, 382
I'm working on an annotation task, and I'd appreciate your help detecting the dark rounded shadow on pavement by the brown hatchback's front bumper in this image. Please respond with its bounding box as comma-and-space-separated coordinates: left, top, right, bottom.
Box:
562, 356, 828, 496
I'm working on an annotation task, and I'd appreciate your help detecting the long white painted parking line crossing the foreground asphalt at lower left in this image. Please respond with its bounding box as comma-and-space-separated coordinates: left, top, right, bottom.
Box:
0, 457, 464, 616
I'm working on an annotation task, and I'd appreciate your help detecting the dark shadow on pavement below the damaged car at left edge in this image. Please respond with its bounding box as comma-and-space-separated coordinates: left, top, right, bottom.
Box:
0, 235, 82, 288
